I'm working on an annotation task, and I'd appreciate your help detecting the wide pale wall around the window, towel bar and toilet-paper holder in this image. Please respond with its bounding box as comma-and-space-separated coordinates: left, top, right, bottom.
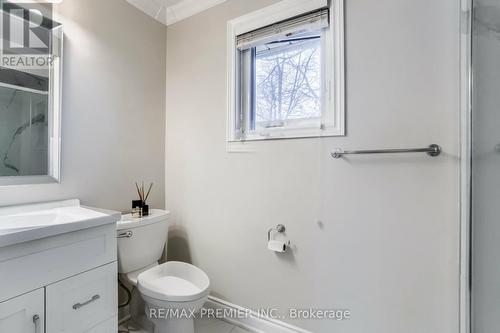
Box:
166, 0, 459, 333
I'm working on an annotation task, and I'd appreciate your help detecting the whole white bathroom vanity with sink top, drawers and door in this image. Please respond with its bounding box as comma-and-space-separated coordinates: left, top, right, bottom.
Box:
0, 200, 120, 333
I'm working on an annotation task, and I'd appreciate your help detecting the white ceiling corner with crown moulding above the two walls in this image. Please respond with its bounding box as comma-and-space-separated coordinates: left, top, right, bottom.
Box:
127, 0, 226, 25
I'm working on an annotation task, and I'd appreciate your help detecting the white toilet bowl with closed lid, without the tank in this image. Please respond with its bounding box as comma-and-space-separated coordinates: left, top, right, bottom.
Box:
137, 261, 210, 333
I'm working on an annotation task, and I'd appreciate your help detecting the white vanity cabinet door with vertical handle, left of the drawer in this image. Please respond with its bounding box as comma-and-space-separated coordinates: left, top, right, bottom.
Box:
0, 288, 45, 333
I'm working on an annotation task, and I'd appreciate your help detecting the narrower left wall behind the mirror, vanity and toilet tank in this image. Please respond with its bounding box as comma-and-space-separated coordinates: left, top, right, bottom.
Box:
0, 0, 166, 210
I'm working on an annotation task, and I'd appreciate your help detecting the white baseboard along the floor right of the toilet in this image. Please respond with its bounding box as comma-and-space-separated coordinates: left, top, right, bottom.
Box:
205, 296, 312, 333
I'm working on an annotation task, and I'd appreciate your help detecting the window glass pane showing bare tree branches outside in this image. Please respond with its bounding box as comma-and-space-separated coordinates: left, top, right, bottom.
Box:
255, 38, 321, 127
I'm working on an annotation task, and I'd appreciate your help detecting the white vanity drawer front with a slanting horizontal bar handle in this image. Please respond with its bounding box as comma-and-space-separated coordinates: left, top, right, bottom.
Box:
46, 262, 118, 333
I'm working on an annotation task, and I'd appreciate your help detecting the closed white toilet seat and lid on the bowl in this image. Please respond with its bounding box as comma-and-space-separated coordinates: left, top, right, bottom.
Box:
137, 261, 210, 302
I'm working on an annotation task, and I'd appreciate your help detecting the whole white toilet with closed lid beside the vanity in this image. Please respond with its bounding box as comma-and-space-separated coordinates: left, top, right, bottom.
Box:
117, 209, 210, 333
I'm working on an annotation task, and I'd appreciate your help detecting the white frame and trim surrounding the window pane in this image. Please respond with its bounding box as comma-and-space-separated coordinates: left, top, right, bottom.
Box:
227, 0, 345, 142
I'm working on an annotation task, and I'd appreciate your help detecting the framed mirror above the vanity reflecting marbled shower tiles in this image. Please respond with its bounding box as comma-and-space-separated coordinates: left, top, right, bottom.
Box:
0, 6, 63, 186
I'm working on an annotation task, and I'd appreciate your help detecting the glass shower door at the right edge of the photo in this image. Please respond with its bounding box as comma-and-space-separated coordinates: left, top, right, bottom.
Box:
471, 0, 500, 333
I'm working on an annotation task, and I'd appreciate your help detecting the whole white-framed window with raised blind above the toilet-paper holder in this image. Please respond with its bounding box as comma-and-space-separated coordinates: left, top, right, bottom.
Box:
228, 0, 344, 141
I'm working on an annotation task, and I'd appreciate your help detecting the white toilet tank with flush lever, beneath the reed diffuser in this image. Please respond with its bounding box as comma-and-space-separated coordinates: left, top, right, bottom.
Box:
117, 209, 169, 273
